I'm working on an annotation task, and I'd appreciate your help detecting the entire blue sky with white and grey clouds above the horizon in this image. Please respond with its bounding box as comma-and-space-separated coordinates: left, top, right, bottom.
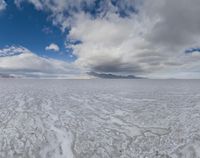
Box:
0, 0, 200, 79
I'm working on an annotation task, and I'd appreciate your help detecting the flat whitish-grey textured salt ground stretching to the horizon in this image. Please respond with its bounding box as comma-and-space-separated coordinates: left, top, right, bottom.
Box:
0, 79, 200, 158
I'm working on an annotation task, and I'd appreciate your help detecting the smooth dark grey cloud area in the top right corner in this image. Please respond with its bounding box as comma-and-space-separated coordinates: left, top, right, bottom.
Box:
150, 0, 200, 48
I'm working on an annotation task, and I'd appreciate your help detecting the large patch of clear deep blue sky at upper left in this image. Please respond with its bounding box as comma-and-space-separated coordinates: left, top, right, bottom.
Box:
0, 0, 75, 61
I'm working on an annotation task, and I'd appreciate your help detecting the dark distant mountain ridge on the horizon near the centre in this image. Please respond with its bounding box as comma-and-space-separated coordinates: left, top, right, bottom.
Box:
88, 72, 142, 79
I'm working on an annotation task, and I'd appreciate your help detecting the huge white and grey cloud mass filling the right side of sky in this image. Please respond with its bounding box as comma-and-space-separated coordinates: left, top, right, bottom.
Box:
12, 0, 200, 78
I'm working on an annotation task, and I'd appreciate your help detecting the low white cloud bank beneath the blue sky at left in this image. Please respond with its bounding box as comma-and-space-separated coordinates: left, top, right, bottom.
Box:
0, 46, 84, 78
